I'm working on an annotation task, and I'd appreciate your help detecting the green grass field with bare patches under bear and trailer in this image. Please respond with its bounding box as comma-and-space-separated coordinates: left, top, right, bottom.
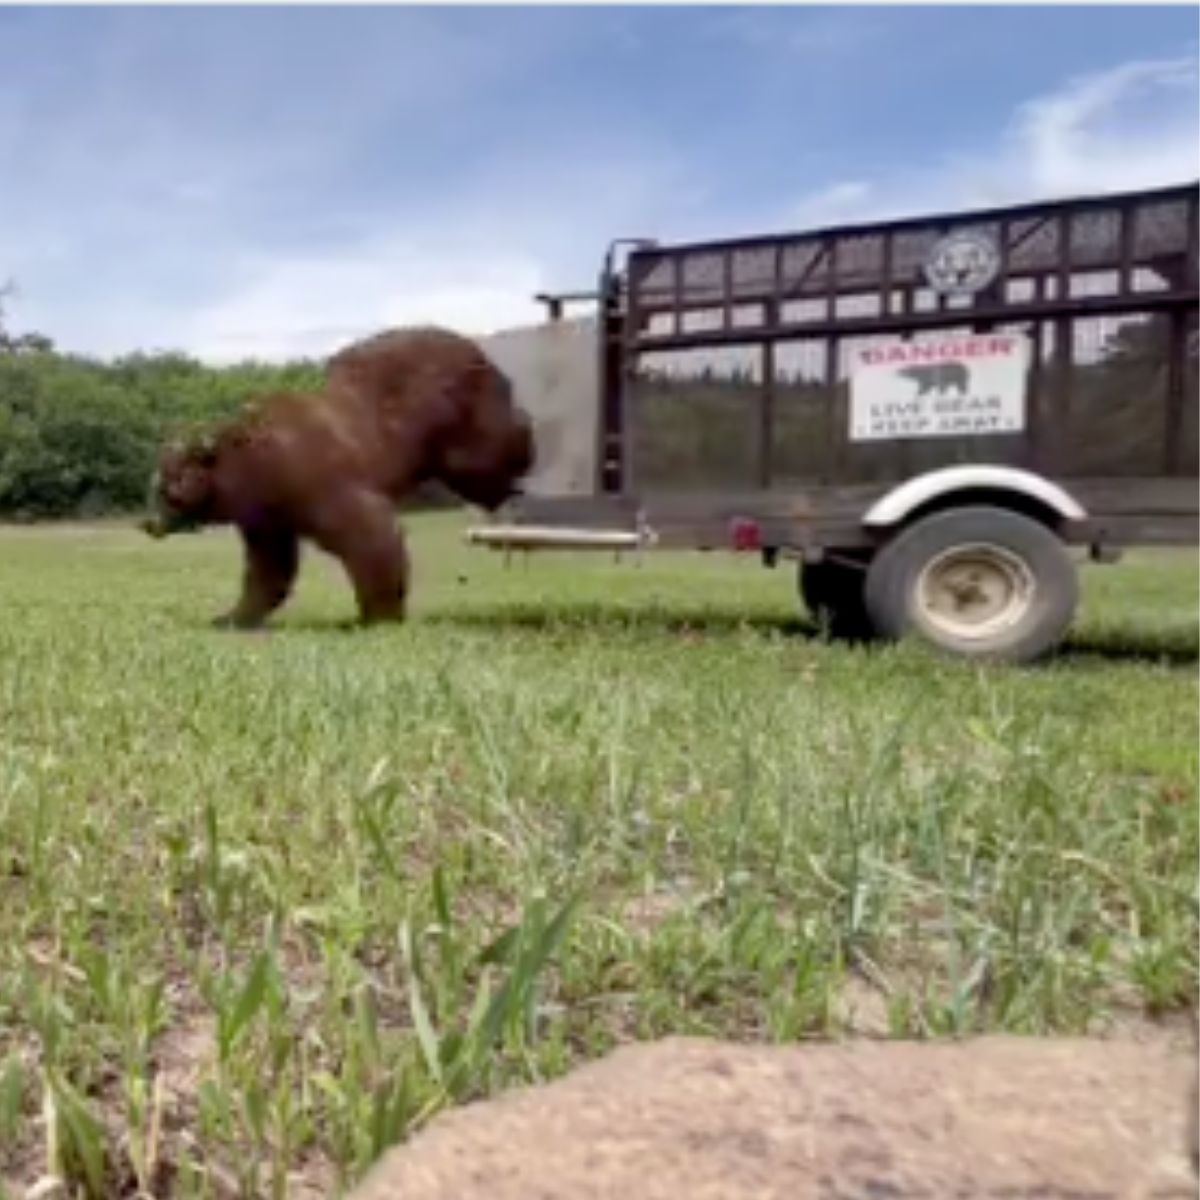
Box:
0, 516, 1198, 1196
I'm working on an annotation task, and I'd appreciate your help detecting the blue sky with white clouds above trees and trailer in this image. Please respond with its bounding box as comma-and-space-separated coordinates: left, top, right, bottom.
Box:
0, 5, 1200, 362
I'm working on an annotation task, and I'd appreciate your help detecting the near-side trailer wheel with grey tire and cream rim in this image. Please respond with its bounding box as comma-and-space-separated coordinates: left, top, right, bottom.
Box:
864, 506, 1079, 664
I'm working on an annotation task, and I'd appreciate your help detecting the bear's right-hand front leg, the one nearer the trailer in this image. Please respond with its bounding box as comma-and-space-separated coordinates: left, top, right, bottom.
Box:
313, 491, 409, 625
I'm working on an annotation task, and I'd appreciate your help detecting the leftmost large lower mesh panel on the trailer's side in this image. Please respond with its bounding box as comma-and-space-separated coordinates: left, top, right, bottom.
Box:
626, 347, 763, 492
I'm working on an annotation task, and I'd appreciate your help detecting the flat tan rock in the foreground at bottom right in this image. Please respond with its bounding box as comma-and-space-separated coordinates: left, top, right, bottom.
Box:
354, 1038, 1196, 1200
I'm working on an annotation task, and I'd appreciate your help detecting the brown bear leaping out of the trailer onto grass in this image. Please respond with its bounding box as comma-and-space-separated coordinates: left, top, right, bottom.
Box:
143, 328, 534, 629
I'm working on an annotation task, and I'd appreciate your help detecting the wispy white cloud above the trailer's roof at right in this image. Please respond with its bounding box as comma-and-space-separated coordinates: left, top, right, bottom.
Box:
786, 58, 1200, 228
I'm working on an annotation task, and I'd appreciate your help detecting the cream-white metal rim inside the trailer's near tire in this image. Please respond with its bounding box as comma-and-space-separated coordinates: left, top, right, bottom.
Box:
913, 542, 1037, 642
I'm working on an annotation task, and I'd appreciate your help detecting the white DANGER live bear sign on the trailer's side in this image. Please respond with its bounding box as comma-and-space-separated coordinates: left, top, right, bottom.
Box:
850, 334, 1028, 442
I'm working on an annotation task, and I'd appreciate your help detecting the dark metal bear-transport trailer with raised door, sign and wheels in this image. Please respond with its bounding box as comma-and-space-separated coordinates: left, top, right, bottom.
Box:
468, 184, 1200, 661
